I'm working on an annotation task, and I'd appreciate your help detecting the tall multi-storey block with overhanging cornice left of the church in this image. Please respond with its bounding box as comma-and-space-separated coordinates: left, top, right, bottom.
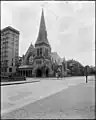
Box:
1, 26, 20, 74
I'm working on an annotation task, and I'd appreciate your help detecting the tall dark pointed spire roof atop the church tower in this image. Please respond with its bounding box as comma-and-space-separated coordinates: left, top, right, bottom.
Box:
35, 9, 50, 46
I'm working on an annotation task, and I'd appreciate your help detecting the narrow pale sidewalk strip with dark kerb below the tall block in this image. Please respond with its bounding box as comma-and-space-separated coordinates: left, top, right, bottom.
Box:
1, 78, 40, 86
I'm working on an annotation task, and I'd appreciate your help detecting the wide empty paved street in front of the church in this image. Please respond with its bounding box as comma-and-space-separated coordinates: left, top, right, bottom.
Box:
1, 76, 95, 119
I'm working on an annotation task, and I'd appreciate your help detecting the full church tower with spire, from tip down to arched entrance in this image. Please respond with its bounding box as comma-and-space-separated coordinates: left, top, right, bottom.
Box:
34, 9, 51, 76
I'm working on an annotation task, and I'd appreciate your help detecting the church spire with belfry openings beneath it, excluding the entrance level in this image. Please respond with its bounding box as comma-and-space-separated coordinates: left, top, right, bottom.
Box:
35, 9, 51, 61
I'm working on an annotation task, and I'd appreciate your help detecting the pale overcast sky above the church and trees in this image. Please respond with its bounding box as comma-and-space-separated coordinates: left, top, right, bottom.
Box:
1, 1, 96, 66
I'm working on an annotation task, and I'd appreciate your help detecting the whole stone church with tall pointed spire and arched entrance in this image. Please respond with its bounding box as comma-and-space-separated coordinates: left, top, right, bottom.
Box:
18, 9, 67, 77
